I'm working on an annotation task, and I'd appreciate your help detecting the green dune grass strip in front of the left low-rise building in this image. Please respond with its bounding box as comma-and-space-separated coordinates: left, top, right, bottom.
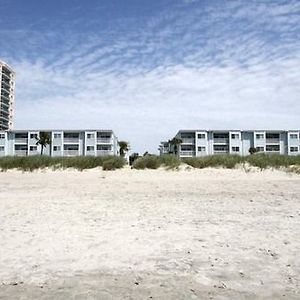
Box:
0, 155, 126, 171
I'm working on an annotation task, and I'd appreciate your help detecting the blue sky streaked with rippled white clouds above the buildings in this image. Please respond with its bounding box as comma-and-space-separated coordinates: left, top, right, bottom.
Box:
0, 0, 300, 153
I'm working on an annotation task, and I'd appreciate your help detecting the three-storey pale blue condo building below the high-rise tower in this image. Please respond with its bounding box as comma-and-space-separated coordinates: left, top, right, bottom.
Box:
0, 129, 118, 157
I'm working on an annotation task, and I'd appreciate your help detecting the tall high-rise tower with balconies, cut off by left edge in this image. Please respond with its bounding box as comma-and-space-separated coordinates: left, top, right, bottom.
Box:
0, 60, 15, 130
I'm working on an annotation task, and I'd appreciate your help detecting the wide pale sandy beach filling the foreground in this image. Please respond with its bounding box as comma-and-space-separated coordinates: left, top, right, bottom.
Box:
0, 169, 300, 299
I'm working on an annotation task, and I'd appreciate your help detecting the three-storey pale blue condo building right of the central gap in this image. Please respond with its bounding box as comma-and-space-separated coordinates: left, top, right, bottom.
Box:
159, 130, 300, 158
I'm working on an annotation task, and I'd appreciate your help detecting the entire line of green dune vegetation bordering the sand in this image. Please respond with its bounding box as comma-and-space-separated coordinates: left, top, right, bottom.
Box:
0, 154, 300, 174
